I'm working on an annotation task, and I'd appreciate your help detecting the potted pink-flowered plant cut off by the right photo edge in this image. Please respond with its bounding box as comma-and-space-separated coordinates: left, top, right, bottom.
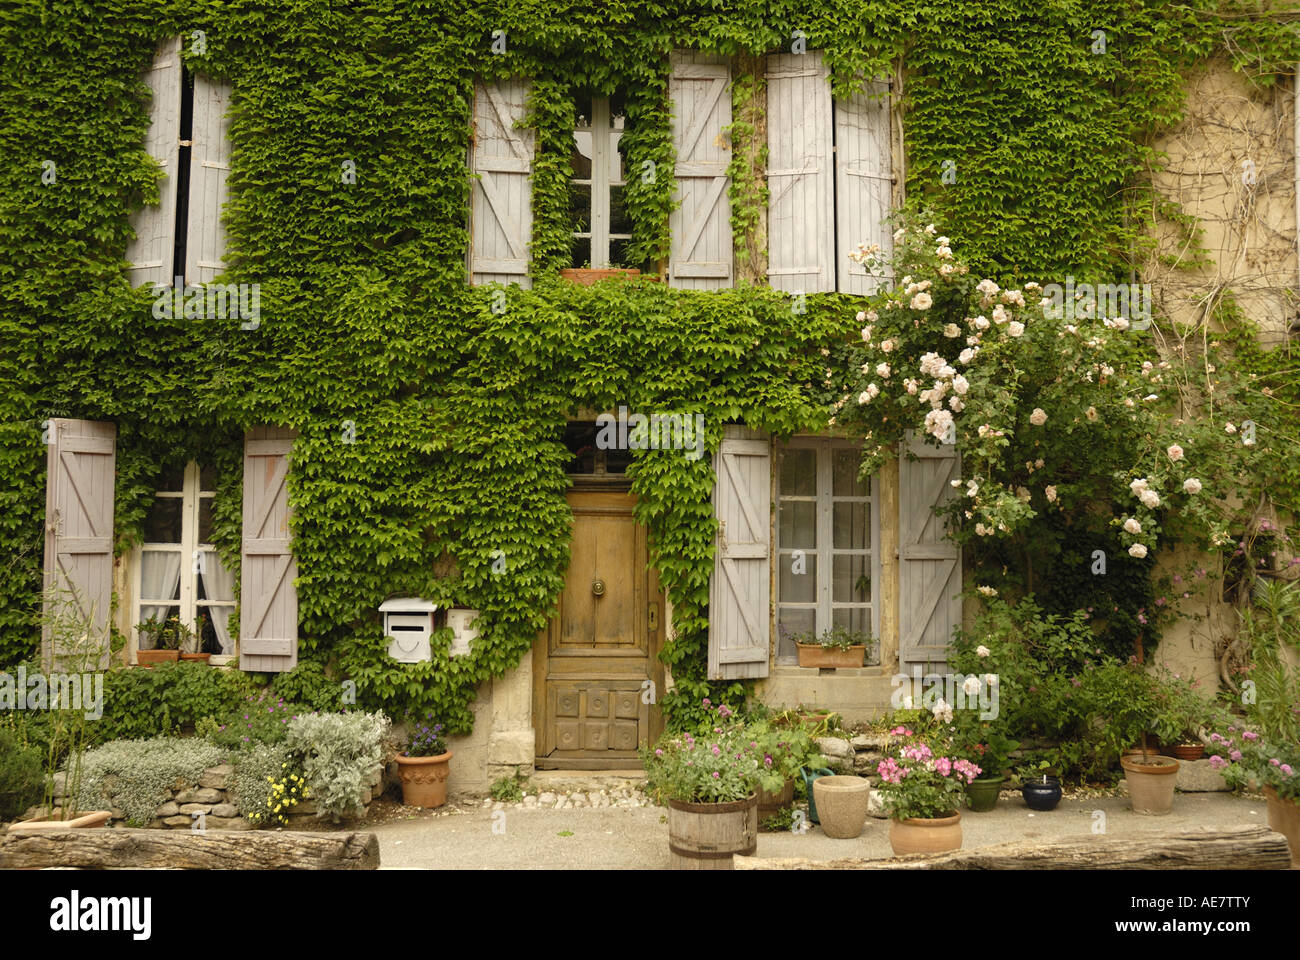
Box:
1209, 725, 1300, 869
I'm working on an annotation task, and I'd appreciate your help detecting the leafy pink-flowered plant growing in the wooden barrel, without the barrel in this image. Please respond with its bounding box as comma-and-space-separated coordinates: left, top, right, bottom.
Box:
641, 704, 785, 804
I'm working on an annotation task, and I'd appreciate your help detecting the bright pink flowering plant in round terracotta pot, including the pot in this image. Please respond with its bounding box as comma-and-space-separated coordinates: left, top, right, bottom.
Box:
876, 726, 982, 856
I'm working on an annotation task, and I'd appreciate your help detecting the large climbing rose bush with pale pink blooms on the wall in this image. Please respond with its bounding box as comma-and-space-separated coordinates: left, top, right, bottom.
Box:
827, 213, 1258, 559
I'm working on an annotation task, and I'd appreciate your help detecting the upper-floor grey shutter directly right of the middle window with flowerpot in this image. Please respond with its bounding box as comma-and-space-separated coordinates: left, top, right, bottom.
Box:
668, 51, 733, 290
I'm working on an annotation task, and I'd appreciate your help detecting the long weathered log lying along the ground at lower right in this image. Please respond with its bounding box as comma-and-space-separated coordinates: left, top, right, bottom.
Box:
735, 825, 1291, 870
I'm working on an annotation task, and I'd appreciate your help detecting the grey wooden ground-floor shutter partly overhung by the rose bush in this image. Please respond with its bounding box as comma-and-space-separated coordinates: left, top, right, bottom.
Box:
898, 434, 962, 667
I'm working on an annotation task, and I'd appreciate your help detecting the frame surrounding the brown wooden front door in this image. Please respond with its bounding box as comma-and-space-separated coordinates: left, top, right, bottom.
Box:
533, 480, 667, 770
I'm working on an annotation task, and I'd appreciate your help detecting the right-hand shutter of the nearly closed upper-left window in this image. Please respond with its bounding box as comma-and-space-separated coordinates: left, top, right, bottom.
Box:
185, 75, 230, 284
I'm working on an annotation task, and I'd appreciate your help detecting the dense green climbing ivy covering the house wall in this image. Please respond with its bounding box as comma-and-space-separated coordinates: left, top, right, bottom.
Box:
0, 0, 1300, 732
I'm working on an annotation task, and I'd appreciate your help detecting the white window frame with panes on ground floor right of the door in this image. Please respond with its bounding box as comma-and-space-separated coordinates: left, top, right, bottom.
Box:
772, 436, 880, 666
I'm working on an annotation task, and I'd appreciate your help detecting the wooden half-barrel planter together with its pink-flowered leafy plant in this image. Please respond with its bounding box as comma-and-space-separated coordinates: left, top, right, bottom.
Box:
641, 705, 783, 870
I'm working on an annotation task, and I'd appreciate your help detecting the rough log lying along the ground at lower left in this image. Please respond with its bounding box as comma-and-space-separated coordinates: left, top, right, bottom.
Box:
0, 829, 380, 870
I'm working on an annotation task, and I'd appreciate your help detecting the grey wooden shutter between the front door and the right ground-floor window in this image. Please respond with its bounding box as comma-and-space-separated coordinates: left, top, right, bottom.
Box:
709, 427, 772, 680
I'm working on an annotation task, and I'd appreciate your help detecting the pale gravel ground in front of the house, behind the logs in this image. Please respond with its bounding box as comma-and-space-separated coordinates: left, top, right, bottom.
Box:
361, 784, 1266, 870
